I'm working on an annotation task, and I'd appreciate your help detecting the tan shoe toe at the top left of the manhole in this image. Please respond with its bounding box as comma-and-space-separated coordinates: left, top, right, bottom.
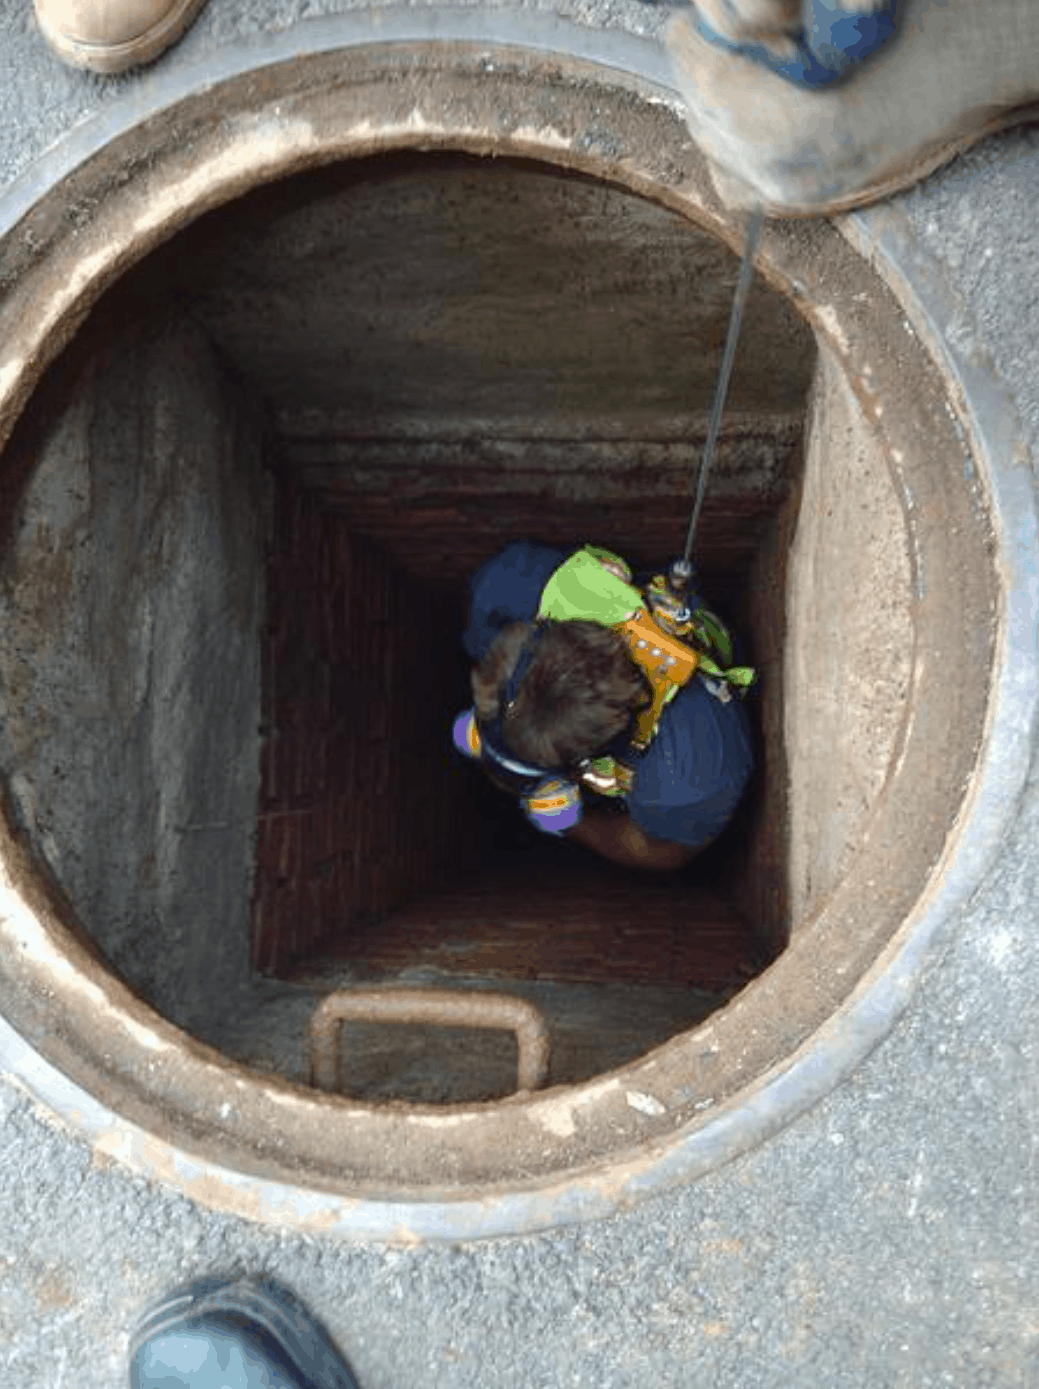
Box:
33, 0, 206, 72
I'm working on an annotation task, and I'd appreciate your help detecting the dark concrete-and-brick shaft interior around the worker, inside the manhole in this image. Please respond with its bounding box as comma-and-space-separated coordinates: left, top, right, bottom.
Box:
3, 154, 927, 1099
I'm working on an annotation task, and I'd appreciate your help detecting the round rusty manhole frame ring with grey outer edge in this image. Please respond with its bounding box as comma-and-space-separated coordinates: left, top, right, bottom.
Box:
0, 10, 1036, 1239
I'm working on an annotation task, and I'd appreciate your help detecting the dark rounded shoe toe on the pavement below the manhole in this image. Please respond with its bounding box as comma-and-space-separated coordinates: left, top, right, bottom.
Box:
129, 1278, 358, 1389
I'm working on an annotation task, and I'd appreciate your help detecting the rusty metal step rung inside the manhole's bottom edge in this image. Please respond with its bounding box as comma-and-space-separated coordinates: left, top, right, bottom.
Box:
310, 989, 549, 1093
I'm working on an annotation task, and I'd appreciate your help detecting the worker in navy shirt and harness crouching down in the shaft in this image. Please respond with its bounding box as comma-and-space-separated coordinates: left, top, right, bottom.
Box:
454, 540, 754, 871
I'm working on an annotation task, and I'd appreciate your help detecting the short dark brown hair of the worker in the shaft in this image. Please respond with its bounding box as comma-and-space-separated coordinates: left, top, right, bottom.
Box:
472, 621, 653, 768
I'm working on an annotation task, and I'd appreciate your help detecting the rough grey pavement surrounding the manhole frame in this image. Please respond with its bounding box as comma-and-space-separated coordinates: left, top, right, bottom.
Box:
0, 0, 1039, 1389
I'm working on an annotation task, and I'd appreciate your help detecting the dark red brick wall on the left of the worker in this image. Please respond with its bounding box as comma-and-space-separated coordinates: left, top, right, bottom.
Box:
253, 476, 476, 974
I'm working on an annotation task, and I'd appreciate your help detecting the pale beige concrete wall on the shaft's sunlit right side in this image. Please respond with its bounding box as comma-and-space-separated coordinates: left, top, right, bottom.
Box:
783, 337, 913, 921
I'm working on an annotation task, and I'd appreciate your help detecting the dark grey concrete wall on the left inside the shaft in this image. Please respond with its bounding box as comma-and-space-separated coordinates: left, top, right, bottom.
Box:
0, 315, 264, 1029
